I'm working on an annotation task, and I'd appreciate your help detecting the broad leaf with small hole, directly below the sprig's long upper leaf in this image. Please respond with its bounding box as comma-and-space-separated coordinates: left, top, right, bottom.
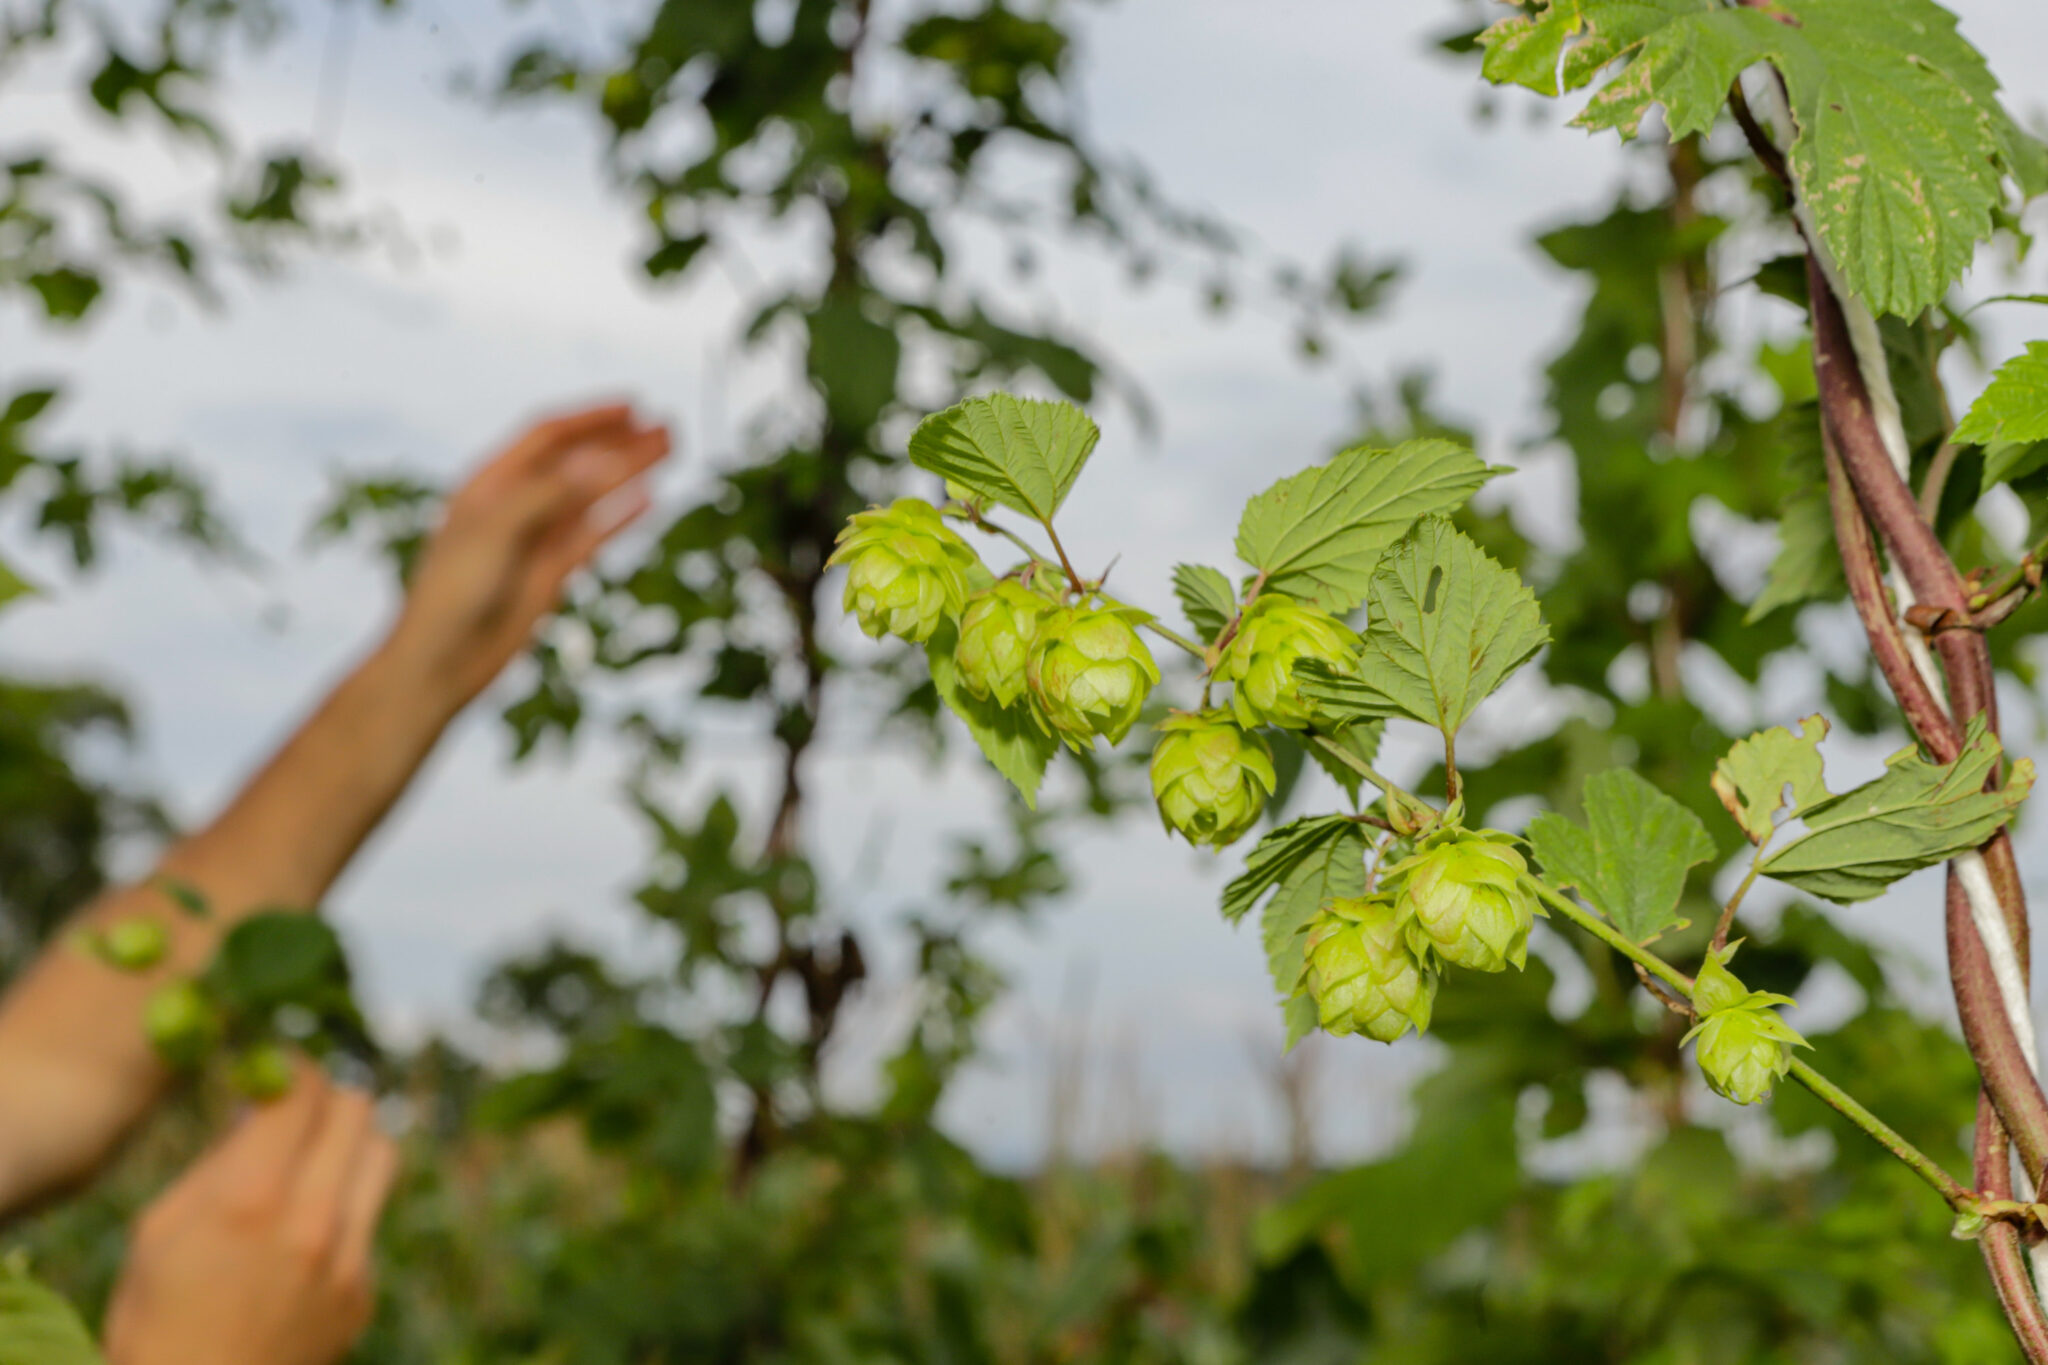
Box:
1298, 516, 1550, 735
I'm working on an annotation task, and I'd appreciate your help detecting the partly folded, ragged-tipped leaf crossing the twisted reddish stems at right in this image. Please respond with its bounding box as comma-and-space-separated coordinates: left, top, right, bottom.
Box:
1759, 716, 2034, 902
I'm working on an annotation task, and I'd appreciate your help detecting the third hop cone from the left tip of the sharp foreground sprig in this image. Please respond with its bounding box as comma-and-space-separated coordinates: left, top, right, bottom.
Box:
1024, 602, 1159, 751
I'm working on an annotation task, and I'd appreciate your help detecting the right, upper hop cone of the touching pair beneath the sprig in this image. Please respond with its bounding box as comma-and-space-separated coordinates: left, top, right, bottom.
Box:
1389, 829, 1542, 972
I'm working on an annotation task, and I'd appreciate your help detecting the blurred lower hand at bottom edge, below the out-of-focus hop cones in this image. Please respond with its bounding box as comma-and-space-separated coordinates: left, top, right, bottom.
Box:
106, 1064, 397, 1365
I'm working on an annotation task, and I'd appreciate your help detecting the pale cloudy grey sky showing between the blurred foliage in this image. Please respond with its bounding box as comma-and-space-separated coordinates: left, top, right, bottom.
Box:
12, 0, 2048, 1162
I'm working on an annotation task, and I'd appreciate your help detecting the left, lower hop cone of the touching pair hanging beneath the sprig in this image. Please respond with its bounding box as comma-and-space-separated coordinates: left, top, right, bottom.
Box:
1305, 896, 1436, 1044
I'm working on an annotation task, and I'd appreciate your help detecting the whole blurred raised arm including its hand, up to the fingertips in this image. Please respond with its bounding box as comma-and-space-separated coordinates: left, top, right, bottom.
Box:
0, 397, 670, 1216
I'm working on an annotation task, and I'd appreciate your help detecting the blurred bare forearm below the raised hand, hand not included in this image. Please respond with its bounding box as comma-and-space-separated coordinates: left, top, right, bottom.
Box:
0, 634, 461, 1214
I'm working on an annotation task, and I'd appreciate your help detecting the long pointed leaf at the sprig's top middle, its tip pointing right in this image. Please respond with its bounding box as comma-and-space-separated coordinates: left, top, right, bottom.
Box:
1237, 440, 1499, 616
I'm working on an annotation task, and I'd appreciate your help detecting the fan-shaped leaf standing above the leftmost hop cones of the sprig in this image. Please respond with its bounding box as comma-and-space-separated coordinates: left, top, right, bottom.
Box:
909, 393, 1102, 522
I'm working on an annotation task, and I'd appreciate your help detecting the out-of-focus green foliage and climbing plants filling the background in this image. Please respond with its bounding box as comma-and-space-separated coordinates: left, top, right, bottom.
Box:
0, 0, 2048, 1365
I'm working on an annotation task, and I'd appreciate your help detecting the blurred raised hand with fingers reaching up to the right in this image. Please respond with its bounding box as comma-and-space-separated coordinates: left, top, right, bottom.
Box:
391, 403, 670, 708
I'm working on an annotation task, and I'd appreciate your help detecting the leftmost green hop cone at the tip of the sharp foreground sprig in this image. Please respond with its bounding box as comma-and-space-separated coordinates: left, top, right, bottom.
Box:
827, 497, 979, 645
